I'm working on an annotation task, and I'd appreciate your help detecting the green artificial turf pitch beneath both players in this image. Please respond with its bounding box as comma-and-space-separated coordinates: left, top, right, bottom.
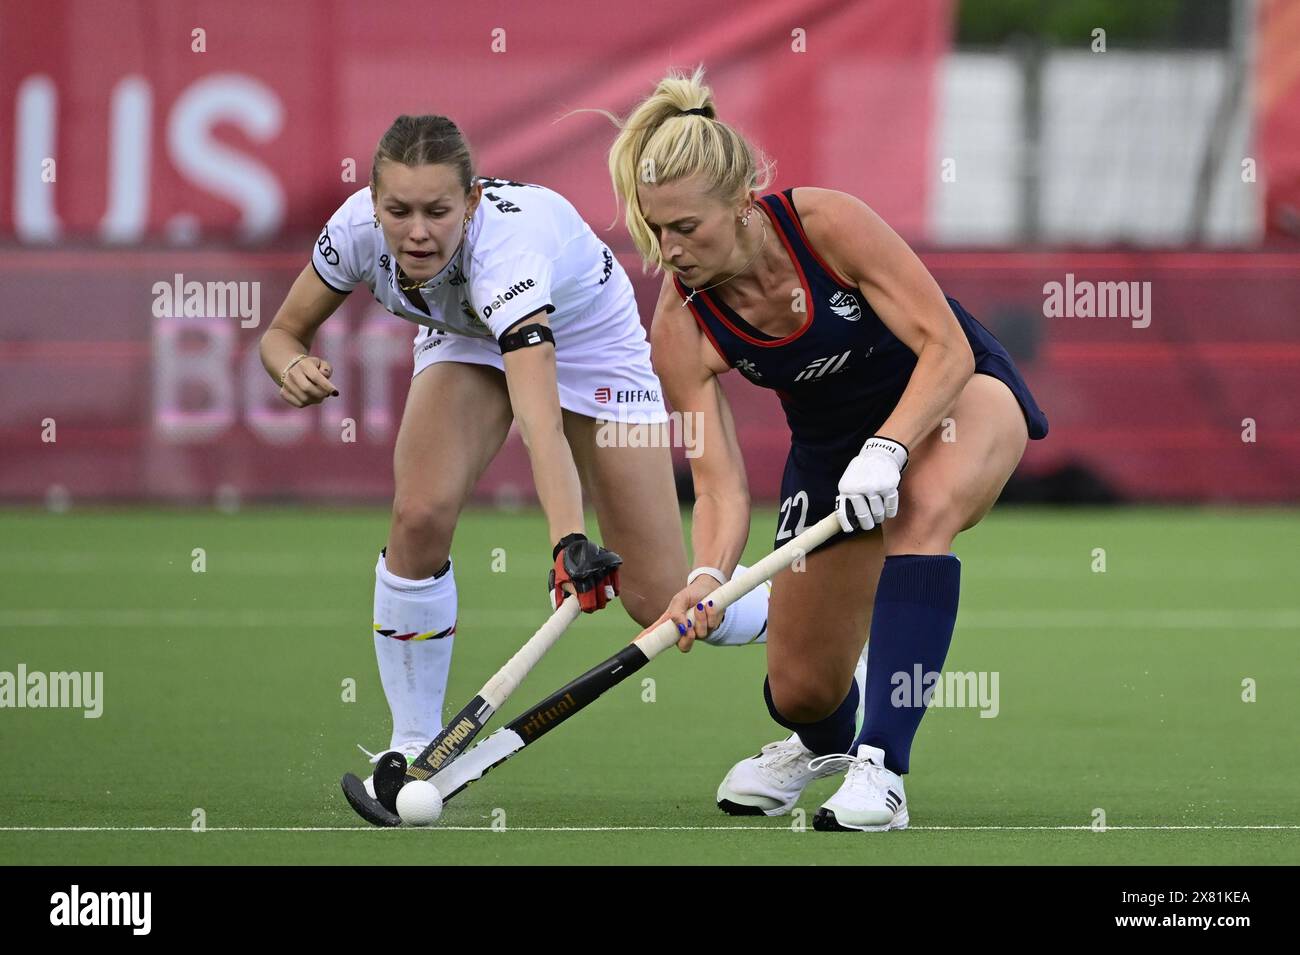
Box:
0, 508, 1300, 865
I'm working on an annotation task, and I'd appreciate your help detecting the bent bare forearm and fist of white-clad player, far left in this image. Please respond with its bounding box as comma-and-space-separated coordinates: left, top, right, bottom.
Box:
259, 262, 347, 408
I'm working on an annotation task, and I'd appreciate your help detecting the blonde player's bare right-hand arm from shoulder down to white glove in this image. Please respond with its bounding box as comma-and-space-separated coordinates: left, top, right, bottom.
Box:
796, 188, 975, 448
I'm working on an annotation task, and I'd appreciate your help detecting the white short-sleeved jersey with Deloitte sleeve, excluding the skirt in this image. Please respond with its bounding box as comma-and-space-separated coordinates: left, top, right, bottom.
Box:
312, 179, 620, 344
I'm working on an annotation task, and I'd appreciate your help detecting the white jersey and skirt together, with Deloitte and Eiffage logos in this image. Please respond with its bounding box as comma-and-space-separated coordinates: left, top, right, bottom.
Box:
312, 179, 667, 424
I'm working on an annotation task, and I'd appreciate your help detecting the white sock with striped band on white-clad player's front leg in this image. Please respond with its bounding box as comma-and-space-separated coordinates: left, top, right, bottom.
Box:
374, 554, 456, 750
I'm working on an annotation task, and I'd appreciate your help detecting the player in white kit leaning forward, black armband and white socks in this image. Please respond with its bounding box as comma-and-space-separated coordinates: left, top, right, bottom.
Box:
261, 116, 767, 779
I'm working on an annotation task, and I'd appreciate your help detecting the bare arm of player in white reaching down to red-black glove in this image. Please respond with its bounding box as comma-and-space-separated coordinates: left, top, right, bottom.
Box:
504, 312, 582, 543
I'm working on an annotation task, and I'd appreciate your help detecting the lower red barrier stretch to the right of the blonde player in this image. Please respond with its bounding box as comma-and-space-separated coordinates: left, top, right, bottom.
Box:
923, 252, 1300, 503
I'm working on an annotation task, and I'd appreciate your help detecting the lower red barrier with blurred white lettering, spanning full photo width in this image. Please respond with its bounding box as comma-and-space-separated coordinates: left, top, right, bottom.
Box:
0, 251, 1300, 502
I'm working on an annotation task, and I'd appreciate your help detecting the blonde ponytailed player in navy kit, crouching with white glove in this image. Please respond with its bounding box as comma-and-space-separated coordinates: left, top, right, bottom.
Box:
610, 70, 1048, 830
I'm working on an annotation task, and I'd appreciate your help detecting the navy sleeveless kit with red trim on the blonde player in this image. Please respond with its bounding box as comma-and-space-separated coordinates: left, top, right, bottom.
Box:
673, 190, 1048, 543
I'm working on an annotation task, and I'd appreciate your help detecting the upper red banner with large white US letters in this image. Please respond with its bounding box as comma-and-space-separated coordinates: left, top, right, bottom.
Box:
0, 0, 950, 243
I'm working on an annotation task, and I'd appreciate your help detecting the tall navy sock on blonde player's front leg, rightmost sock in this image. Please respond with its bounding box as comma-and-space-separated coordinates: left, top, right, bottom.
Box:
853, 554, 962, 774
